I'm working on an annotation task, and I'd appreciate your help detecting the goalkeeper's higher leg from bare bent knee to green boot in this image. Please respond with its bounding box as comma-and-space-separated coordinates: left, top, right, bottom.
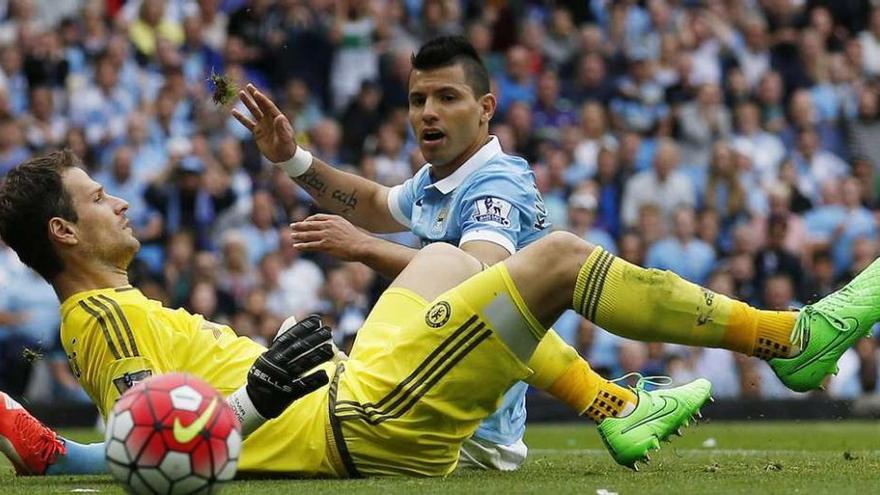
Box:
505, 233, 880, 391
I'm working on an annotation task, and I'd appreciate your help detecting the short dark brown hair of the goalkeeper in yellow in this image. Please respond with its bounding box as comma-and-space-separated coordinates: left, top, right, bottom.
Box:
0, 149, 79, 282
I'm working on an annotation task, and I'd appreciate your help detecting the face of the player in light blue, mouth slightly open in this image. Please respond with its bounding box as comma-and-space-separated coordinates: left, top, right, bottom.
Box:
409, 64, 495, 167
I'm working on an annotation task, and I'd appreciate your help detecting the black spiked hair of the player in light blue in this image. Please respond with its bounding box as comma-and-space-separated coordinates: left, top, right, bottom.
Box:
412, 36, 489, 98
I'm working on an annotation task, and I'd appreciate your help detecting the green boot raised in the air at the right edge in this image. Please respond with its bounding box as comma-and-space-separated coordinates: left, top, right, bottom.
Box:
768, 260, 880, 392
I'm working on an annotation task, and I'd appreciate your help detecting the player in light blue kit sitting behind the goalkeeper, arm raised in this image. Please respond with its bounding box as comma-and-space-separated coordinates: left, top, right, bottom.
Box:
233, 37, 561, 470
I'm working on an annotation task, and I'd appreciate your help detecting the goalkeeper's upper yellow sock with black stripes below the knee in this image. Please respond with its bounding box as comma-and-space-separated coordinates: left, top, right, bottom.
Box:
572, 247, 796, 357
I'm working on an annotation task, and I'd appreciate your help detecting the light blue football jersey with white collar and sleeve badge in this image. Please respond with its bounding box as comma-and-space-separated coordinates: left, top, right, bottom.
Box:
388, 136, 550, 445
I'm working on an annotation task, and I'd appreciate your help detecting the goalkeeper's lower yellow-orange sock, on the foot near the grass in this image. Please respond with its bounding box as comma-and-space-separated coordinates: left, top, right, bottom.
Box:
527, 329, 637, 423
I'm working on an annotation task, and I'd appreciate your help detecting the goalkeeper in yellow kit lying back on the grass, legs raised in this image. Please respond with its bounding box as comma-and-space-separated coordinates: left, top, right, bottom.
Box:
0, 146, 880, 477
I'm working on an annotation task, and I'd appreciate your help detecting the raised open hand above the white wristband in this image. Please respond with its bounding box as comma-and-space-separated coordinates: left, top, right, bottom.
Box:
232, 84, 296, 163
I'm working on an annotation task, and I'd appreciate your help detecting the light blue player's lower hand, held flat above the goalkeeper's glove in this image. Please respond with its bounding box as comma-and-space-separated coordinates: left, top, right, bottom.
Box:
290, 213, 372, 261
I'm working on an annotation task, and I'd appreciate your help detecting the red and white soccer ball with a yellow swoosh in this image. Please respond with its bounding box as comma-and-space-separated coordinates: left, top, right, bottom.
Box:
104, 373, 241, 495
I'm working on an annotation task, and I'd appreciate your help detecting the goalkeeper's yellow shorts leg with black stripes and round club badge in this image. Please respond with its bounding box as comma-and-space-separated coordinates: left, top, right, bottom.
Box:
333, 268, 531, 475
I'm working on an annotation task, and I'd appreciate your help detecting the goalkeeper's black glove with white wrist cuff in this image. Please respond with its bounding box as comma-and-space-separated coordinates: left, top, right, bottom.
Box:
227, 316, 333, 437
